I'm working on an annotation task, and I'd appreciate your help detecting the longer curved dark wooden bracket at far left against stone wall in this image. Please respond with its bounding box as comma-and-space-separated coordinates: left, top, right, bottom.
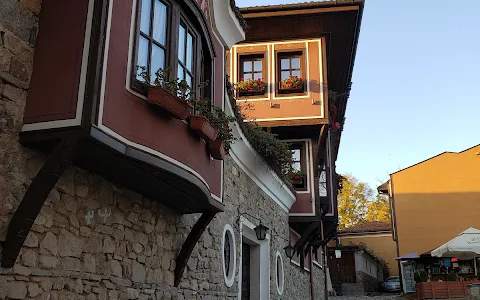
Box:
2, 137, 78, 268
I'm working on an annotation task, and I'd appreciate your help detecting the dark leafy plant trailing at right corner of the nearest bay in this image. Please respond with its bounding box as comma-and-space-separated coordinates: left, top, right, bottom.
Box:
193, 97, 236, 155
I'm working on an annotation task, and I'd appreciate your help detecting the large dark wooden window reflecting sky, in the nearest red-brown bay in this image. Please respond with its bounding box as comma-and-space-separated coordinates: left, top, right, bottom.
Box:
131, 0, 207, 96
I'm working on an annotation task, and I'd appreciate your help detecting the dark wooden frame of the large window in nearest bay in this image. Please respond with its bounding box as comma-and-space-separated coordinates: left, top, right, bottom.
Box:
130, 0, 206, 97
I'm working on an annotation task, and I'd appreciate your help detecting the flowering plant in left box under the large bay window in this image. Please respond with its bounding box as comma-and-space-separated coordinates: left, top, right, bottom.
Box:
137, 66, 193, 101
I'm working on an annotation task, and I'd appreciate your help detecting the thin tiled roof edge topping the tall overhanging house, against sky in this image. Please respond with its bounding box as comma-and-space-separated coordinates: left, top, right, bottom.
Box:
240, 0, 364, 13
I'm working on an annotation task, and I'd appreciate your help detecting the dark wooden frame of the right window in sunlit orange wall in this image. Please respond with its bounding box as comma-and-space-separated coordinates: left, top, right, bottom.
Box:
275, 49, 308, 97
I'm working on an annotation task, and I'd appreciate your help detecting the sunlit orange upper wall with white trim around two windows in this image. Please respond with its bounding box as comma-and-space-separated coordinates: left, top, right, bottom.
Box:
227, 39, 328, 126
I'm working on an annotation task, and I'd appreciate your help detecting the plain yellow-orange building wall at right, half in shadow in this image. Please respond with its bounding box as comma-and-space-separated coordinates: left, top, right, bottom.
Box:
391, 145, 480, 255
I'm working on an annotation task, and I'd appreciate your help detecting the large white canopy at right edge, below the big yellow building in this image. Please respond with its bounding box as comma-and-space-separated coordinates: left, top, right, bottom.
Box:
431, 227, 480, 259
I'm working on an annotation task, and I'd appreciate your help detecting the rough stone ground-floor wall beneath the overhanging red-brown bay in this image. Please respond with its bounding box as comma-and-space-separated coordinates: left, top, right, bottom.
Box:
0, 0, 324, 300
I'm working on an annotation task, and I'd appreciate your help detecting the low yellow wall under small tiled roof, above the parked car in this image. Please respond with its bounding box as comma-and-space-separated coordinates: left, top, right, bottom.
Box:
338, 233, 398, 276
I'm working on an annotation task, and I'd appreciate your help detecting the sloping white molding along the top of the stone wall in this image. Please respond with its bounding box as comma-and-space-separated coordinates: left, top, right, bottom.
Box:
225, 90, 296, 212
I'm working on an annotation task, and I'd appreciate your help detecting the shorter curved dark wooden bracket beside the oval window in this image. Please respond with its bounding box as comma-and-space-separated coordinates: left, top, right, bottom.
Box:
173, 211, 217, 287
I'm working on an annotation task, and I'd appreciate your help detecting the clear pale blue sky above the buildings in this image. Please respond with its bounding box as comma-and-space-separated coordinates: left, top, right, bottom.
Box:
236, 0, 480, 187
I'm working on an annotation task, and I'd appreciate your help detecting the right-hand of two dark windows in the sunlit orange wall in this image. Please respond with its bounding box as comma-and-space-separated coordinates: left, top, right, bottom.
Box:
277, 51, 306, 94
